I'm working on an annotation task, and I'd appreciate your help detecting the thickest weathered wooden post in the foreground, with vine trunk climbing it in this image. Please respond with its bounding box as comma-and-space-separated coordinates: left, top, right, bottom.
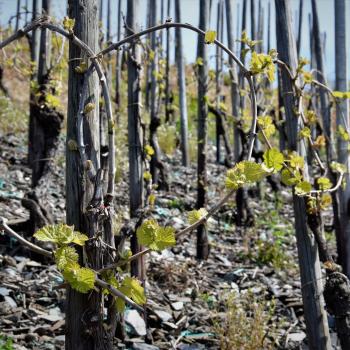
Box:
66, 0, 112, 350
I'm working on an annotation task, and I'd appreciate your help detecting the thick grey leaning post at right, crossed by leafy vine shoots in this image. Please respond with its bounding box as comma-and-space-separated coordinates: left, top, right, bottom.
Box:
275, 0, 331, 350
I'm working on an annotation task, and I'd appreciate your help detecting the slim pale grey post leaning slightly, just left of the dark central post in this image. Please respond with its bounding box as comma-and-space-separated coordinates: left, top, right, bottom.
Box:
174, 0, 190, 167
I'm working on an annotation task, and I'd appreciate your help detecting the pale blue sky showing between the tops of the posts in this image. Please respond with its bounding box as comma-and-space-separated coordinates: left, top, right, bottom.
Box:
0, 0, 350, 84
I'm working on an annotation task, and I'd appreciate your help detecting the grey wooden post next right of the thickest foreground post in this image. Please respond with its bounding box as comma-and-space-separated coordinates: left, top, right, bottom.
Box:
126, 0, 144, 277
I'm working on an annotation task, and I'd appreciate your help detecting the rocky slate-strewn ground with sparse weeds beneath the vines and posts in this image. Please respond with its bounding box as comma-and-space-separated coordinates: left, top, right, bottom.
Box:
0, 131, 336, 350
